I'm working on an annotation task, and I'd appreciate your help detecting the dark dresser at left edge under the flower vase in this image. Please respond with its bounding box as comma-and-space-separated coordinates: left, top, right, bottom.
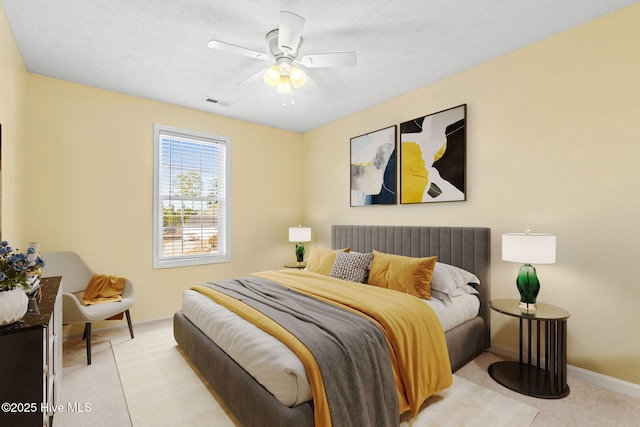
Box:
0, 277, 66, 426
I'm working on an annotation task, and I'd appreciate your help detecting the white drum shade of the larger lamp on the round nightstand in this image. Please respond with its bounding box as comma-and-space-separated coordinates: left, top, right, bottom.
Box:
502, 233, 556, 264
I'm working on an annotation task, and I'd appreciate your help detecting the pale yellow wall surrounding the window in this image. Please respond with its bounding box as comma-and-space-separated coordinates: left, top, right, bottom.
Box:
22, 74, 302, 330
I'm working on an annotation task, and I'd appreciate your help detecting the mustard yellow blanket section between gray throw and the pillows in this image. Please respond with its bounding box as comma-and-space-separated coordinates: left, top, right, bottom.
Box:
254, 270, 453, 415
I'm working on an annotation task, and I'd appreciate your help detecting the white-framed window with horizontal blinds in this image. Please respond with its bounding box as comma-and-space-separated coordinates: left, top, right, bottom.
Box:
153, 124, 230, 268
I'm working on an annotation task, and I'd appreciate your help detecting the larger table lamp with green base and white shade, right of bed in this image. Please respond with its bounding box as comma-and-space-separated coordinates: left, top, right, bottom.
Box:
502, 230, 556, 310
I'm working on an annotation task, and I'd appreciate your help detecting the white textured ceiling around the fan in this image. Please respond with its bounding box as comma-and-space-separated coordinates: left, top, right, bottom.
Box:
3, 0, 635, 132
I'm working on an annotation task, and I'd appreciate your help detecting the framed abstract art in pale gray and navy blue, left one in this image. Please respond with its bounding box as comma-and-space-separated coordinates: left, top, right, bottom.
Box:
351, 125, 397, 206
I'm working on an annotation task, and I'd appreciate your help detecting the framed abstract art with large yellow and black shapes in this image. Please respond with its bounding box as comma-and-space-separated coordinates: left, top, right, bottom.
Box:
400, 104, 467, 204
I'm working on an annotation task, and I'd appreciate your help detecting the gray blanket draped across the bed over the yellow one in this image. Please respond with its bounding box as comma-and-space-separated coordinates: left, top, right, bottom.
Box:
206, 277, 400, 427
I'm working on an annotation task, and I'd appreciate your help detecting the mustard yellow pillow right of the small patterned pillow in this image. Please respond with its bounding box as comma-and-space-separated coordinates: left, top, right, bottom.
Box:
369, 250, 438, 299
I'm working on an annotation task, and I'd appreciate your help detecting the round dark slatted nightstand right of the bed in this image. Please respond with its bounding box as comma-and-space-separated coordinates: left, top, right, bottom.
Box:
489, 299, 569, 399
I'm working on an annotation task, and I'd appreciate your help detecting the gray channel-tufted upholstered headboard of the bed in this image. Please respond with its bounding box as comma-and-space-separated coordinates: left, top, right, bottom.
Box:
331, 225, 491, 348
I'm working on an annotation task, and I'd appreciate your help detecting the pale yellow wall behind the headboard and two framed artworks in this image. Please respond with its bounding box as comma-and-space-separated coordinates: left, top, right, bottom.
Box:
303, 4, 640, 384
